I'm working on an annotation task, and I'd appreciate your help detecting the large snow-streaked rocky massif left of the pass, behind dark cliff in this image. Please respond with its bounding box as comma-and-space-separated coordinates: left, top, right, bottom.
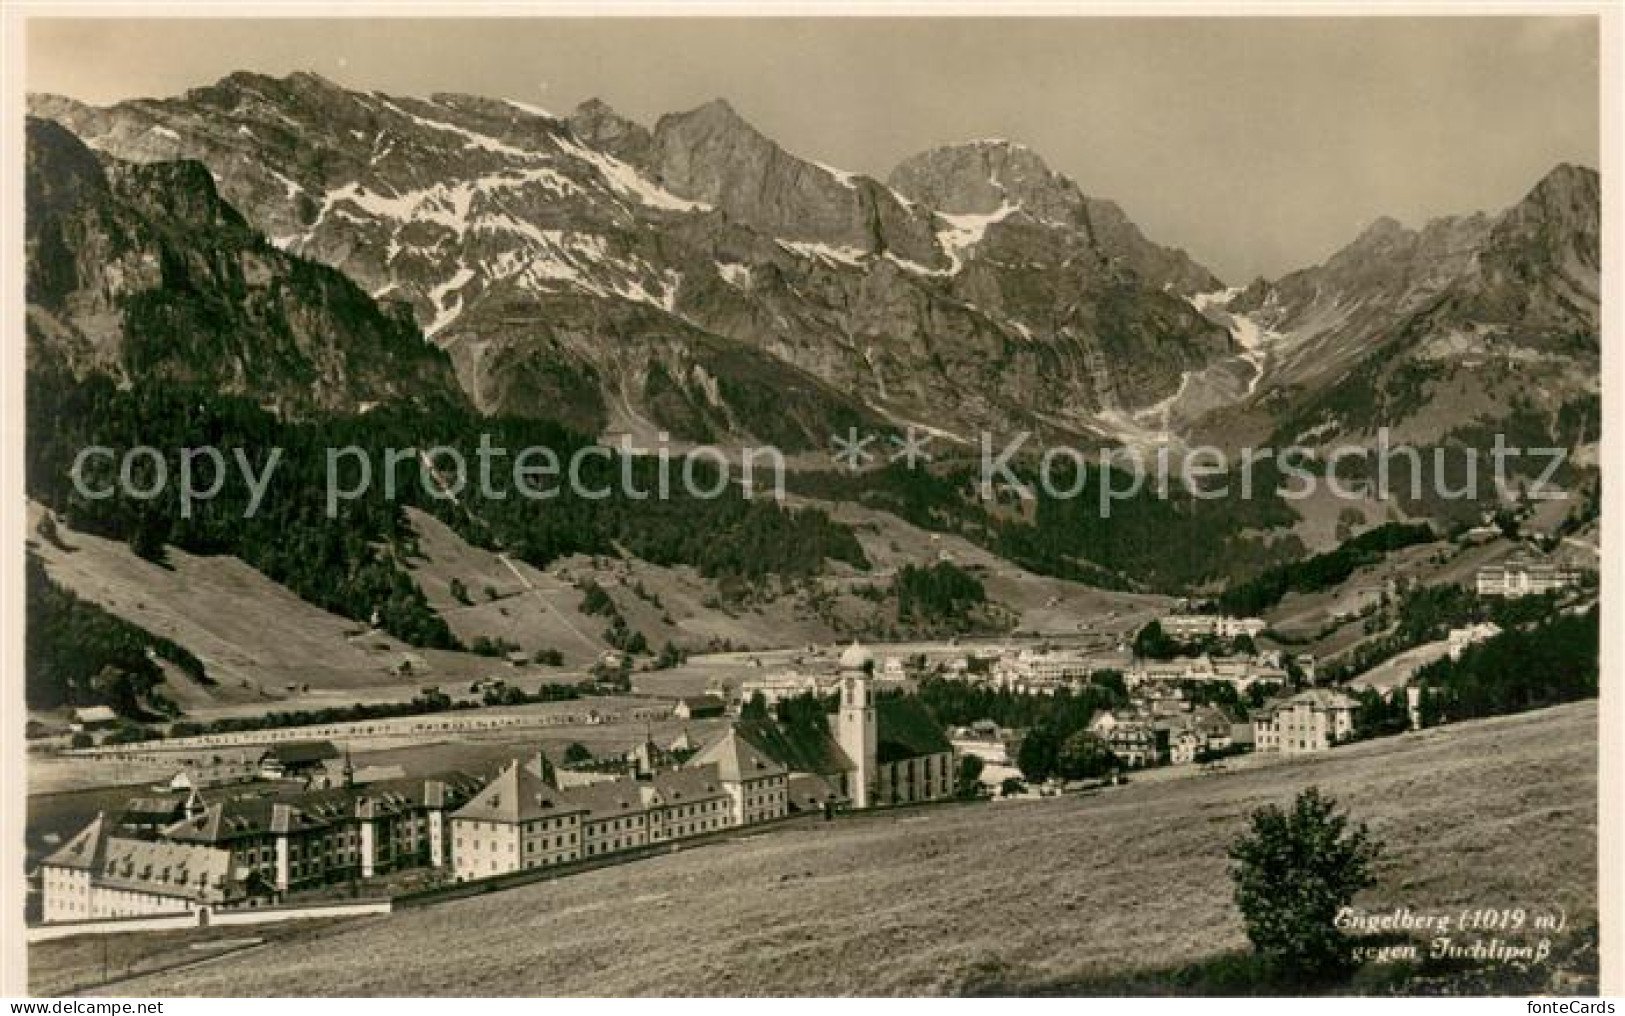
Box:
31, 73, 1232, 447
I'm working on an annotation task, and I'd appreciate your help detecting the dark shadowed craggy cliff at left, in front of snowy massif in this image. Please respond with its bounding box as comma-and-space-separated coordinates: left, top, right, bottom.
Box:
24, 119, 462, 413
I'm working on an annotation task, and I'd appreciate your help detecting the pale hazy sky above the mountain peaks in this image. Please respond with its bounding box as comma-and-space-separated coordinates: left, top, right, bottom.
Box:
28, 16, 1599, 283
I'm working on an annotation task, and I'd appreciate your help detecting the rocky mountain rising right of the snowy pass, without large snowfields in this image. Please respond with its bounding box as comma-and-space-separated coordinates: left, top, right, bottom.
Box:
1168, 164, 1601, 445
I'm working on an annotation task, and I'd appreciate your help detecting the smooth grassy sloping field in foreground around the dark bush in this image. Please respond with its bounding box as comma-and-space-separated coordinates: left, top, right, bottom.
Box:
92, 702, 1597, 996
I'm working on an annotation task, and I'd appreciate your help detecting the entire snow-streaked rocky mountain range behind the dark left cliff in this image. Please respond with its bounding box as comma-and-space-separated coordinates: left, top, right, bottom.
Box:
31, 73, 1599, 450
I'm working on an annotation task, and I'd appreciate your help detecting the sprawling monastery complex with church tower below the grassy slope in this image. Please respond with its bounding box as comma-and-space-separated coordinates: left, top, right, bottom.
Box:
41, 645, 956, 920
